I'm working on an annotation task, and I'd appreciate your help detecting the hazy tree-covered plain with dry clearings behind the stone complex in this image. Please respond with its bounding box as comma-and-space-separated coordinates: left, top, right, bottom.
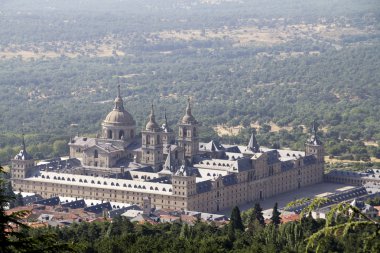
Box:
0, 0, 380, 161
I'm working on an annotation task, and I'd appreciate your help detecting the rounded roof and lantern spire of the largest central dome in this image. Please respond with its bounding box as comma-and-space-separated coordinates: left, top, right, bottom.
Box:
103, 85, 136, 126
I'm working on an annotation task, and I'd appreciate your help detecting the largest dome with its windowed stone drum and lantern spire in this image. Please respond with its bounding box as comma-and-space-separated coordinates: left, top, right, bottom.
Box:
102, 85, 136, 142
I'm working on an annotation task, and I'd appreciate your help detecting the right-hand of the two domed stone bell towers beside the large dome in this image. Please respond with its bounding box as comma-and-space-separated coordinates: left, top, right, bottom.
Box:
178, 98, 199, 161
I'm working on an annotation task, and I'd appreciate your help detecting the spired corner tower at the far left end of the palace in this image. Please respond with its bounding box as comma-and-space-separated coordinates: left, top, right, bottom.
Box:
11, 133, 34, 179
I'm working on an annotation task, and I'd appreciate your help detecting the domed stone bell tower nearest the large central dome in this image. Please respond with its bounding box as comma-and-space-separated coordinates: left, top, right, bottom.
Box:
141, 104, 163, 171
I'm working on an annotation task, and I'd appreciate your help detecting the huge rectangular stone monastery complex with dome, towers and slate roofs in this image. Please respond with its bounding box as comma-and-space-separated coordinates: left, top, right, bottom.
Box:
12, 86, 324, 212
